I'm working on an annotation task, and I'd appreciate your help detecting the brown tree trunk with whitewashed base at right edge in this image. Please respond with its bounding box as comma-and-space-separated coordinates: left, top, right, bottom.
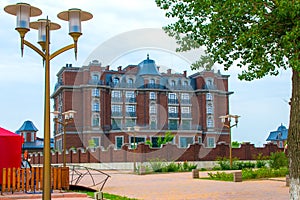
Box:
288, 70, 300, 200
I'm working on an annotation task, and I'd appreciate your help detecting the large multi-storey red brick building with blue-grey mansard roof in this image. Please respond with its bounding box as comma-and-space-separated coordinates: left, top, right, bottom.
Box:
52, 55, 233, 150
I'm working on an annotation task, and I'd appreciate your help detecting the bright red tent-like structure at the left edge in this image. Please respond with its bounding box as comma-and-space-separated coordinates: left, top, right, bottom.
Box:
0, 127, 23, 184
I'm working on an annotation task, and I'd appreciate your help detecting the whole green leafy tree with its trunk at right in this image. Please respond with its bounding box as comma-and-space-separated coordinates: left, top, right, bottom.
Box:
156, 0, 300, 199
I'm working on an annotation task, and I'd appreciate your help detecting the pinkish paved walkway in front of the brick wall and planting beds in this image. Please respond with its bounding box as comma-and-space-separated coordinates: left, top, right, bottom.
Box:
96, 171, 289, 200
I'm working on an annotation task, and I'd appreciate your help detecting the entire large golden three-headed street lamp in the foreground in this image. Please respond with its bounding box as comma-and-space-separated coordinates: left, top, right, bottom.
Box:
4, 3, 93, 200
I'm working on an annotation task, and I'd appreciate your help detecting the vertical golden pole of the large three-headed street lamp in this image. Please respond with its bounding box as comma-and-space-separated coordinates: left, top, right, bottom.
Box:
43, 20, 51, 200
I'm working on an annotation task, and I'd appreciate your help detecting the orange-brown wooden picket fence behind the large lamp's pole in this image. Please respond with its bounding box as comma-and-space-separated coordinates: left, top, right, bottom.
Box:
1, 167, 69, 194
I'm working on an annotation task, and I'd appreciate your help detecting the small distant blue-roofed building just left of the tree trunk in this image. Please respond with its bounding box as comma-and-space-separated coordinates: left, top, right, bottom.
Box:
267, 124, 288, 148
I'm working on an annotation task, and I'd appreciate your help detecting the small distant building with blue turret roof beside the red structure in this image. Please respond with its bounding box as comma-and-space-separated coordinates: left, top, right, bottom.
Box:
16, 120, 54, 152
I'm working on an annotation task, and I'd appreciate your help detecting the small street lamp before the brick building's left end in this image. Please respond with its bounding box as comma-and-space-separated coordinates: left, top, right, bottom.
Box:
52, 110, 76, 167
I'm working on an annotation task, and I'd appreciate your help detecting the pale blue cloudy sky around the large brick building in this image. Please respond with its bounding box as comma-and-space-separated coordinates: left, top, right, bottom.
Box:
0, 0, 291, 146
